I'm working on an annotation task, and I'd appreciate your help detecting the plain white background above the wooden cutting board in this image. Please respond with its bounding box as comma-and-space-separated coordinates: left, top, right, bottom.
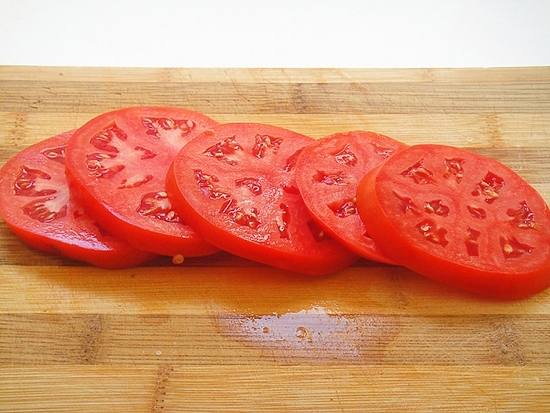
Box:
0, 0, 550, 68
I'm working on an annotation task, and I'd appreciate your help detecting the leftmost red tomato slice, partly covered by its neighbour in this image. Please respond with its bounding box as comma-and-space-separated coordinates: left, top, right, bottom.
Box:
0, 131, 155, 268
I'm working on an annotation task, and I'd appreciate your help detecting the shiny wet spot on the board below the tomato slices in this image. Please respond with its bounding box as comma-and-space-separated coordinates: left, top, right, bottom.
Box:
218, 306, 399, 364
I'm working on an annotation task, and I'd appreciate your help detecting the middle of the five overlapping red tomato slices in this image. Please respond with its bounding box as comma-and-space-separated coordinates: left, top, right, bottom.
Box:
167, 123, 356, 274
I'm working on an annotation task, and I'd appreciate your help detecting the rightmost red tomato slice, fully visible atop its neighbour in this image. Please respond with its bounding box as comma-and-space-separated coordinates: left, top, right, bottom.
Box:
357, 145, 550, 298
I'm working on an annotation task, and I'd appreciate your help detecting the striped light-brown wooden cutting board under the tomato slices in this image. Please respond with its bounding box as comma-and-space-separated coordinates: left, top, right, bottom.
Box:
0, 67, 550, 413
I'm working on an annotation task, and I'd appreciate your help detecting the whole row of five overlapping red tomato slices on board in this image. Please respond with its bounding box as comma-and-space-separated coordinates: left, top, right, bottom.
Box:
0, 107, 550, 298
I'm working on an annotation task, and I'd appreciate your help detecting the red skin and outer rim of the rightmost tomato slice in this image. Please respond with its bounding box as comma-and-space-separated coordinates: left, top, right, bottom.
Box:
357, 144, 550, 299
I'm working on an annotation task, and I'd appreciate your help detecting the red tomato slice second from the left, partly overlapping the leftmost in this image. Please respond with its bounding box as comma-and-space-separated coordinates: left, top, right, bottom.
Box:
67, 107, 217, 256
